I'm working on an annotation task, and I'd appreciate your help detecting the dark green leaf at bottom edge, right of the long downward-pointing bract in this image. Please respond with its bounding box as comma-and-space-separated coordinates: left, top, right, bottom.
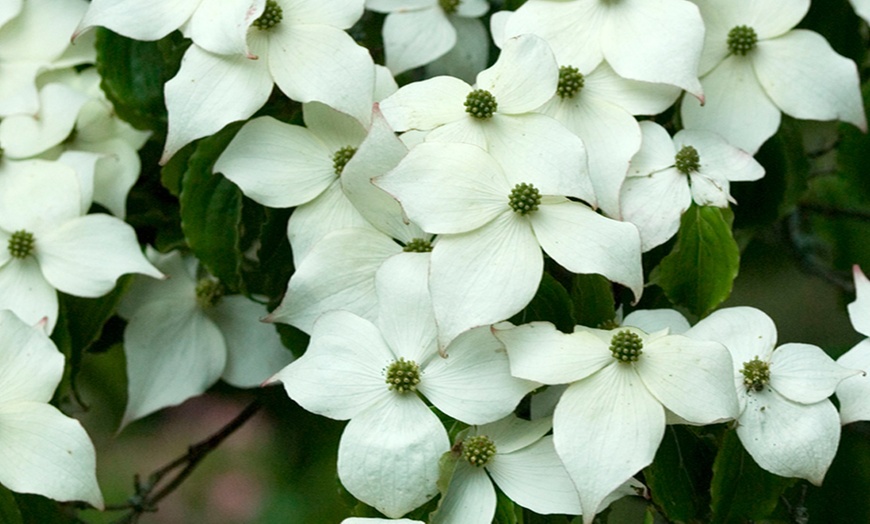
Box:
643, 425, 715, 522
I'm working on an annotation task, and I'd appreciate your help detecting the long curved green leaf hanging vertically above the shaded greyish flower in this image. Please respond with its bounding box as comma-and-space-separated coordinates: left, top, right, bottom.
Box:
180, 122, 243, 290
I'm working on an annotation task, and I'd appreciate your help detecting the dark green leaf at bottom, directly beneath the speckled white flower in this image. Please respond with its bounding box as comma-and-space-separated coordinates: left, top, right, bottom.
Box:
710, 430, 796, 524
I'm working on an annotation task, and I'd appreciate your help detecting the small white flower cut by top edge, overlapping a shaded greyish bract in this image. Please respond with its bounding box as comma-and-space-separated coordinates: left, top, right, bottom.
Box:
366, 0, 489, 75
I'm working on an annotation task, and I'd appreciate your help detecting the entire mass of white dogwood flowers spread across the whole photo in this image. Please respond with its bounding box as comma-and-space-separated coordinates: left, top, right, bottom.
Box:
0, 0, 870, 524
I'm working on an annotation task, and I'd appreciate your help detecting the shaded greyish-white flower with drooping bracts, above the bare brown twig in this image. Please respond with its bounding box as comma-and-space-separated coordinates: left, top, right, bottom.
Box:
119, 248, 293, 427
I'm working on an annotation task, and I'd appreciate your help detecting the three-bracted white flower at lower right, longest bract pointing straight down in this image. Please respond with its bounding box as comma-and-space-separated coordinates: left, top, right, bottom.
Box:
494, 322, 737, 524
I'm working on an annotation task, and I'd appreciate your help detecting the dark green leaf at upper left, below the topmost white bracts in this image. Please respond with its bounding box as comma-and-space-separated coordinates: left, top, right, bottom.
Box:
96, 28, 190, 136
